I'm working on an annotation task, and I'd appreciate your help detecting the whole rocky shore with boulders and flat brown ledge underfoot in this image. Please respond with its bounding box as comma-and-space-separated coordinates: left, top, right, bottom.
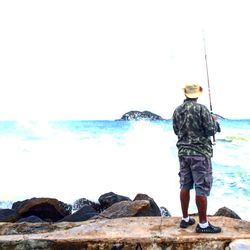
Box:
0, 192, 250, 250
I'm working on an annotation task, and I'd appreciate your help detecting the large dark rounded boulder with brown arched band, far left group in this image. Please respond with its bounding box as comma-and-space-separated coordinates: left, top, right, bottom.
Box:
12, 198, 72, 222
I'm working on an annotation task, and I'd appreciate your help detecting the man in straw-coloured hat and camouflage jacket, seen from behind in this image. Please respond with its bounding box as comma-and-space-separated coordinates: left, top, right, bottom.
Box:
173, 84, 221, 233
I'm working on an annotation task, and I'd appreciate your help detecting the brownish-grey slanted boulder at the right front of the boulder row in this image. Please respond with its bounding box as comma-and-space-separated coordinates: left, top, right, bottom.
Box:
94, 200, 150, 219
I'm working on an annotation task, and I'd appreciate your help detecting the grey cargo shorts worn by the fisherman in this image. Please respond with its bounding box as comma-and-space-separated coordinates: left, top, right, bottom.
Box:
179, 156, 213, 196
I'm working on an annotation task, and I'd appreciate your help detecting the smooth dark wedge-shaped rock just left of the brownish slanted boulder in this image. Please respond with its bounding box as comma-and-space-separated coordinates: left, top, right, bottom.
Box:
60, 204, 98, 222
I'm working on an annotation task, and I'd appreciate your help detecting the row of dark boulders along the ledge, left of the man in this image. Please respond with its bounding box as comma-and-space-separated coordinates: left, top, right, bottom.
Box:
0, 192, 171, 223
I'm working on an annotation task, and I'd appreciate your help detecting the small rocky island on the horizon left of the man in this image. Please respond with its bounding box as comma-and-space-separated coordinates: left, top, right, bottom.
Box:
120, 111, 163, 121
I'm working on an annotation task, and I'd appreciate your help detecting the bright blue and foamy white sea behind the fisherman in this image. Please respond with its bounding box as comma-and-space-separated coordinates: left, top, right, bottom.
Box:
0, 119, 250, 221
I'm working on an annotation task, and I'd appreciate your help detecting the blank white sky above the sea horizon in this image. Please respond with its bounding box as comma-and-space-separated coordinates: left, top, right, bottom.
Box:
0, 0, 250, 119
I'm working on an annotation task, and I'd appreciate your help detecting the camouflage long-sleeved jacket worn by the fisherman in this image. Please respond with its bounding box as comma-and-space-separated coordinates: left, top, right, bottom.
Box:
173, 99, 220, 157
